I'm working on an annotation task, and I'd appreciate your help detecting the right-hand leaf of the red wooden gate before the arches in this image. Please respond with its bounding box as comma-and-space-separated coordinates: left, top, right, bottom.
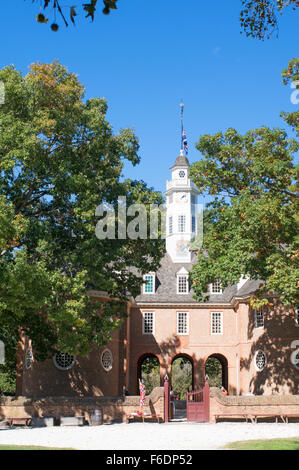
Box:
187, 382, 210, 423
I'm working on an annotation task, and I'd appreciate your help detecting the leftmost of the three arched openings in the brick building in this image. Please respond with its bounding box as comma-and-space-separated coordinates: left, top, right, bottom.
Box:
137, 354, 160, 395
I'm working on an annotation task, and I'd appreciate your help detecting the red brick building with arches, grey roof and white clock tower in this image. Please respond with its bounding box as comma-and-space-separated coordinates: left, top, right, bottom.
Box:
17, 151, 299, 397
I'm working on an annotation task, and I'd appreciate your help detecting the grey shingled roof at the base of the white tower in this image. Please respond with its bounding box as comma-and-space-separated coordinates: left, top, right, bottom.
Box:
135, 253, 260, 305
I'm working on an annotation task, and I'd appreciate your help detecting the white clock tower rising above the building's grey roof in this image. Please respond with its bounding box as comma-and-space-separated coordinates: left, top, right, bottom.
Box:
165, 149, 198, 263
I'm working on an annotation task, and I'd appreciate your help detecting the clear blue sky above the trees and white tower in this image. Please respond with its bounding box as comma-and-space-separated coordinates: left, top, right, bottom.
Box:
0, 0, 299, 198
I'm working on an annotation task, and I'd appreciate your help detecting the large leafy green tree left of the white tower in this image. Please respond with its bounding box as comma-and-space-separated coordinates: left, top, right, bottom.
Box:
0, 62, 164, 366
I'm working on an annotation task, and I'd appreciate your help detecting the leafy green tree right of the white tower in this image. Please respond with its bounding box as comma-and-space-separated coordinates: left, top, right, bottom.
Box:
190, 113, 299, 308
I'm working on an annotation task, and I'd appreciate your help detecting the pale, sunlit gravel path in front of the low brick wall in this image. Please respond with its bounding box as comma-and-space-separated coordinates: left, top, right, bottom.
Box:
0, 423, 299, 450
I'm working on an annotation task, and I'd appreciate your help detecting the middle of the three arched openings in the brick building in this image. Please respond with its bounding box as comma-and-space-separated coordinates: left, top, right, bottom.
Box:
171, 354, 194, 400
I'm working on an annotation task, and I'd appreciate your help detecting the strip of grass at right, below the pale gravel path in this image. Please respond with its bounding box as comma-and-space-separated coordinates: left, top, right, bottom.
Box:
224, 437, 299, 450
